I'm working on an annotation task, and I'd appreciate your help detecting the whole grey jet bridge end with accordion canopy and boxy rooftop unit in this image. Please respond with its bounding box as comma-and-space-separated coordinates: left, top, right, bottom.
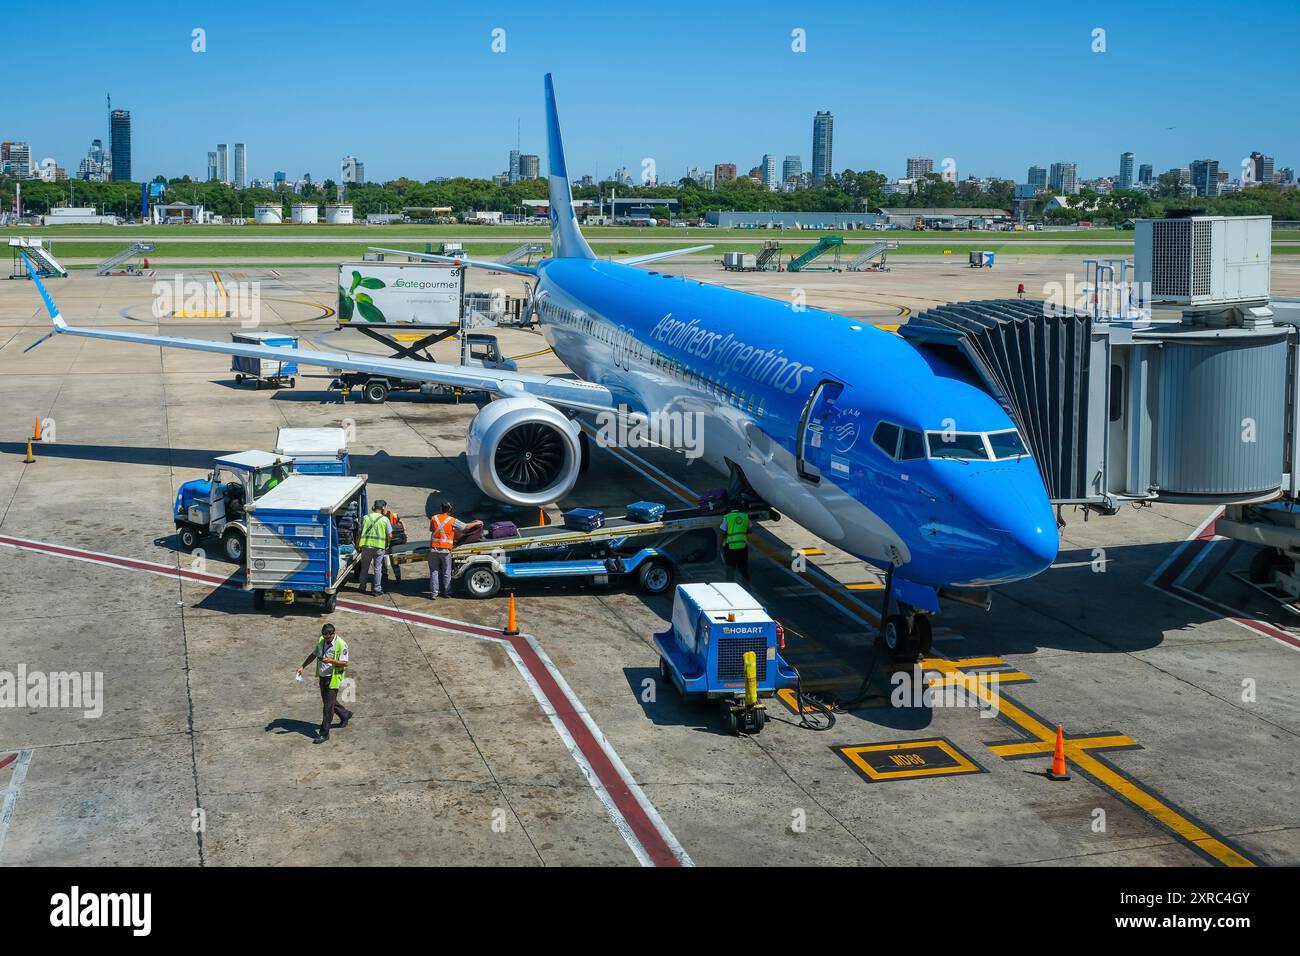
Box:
900, 217, 1300, 514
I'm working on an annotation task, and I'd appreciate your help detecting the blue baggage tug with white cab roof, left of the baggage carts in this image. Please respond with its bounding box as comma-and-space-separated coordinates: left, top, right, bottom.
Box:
173, 451, 294, 562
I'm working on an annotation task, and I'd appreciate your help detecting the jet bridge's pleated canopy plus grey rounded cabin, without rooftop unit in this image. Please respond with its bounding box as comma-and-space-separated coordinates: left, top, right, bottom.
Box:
898, 299, 1300, 511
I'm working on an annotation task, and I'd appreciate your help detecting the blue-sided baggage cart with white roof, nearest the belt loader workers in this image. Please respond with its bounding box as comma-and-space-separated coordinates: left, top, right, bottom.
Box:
243, 475, 368, 614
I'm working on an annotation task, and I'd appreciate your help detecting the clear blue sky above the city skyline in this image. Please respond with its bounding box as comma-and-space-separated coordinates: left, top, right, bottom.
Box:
10, 0, 1300, 181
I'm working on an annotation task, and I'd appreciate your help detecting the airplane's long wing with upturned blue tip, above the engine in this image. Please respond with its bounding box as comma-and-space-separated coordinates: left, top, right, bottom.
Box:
23, 256, 618, 412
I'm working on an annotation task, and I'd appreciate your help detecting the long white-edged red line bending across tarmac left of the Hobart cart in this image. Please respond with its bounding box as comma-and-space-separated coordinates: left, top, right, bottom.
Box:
0, 535, 683, 866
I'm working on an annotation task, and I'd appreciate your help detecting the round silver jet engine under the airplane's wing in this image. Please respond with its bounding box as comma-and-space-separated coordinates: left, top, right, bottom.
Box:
465, 397, 582, 505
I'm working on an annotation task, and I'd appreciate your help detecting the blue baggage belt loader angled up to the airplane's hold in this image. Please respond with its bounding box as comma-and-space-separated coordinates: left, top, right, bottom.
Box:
391, 503, 776, 598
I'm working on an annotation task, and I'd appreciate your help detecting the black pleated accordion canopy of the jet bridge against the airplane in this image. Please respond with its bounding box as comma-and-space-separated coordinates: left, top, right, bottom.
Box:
898, 299, 1104, 502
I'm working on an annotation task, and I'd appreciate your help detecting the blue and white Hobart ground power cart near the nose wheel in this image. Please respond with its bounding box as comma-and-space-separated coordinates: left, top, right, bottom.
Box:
654, 584, 798, 734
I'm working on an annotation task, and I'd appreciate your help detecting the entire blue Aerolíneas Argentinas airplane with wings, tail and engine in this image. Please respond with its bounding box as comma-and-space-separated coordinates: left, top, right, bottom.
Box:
22, 74, 1057, 658
